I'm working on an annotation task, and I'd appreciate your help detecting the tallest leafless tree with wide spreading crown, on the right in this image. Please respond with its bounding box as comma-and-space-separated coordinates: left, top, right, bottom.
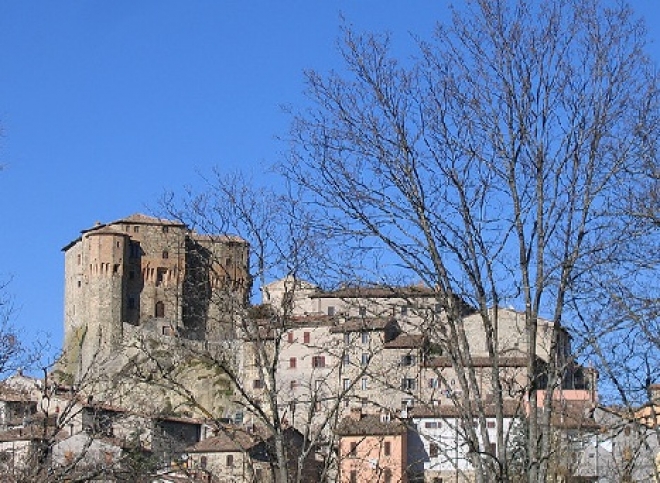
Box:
282, 0, 658, 481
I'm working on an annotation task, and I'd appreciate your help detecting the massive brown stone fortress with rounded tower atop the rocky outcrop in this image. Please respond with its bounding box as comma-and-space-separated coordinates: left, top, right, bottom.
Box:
63, 214, 250, 379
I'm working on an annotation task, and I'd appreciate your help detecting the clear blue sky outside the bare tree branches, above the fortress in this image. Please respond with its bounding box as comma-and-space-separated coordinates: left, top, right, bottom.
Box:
0, 0, 660, 364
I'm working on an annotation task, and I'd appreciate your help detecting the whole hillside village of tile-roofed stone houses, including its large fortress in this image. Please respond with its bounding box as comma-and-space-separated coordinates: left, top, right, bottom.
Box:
0, 214, 660, 483
